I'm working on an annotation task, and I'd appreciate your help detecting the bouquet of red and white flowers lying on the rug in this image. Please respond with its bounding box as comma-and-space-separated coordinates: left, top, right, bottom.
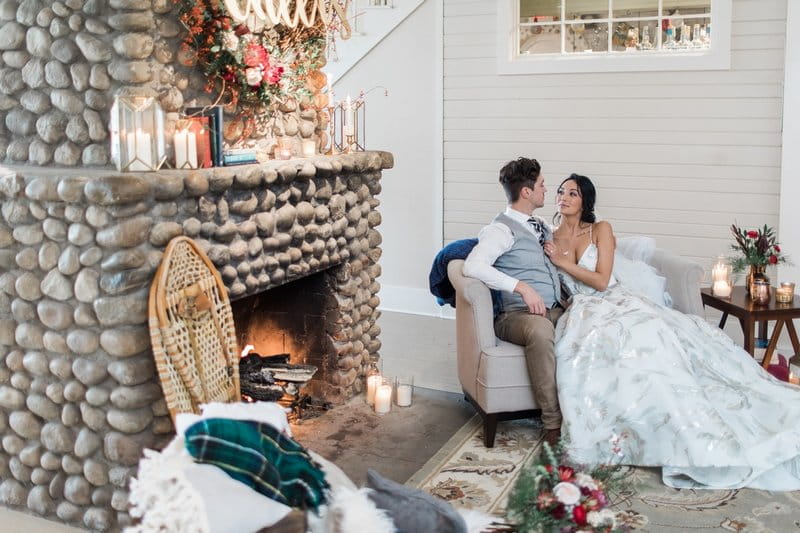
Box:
508, 443, 624, 533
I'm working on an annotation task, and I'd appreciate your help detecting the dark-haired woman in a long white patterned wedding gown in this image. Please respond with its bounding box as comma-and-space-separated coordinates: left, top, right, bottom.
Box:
545, 174, 800, 490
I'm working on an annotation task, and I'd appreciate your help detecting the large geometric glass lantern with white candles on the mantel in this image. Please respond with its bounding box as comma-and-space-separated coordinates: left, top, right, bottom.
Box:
110, 89, 167, 172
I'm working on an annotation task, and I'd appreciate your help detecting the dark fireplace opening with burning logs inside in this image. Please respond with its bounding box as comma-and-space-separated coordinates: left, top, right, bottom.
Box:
231, 267, 340, 418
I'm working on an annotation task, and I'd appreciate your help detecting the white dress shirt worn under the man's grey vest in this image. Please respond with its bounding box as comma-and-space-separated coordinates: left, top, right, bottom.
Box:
464, 206, 547, 292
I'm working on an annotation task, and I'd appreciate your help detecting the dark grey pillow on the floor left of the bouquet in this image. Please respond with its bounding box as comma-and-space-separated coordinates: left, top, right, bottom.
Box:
367, 470, 467, 533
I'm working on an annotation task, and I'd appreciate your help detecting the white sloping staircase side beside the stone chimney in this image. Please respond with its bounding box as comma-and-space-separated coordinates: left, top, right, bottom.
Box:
325, 0, 424, 84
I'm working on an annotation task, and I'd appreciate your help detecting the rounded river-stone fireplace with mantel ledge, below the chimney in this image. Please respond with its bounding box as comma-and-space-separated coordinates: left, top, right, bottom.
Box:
0, 152, 393, 530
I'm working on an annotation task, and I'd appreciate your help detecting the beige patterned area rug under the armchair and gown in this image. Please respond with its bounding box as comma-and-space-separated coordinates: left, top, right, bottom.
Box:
406, 416, 800, 533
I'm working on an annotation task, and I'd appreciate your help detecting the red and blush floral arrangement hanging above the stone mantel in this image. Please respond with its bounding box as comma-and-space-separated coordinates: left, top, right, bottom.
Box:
176, 0, 327, 116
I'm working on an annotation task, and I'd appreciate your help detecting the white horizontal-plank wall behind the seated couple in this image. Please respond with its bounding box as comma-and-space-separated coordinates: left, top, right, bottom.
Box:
444, 0, 796, 266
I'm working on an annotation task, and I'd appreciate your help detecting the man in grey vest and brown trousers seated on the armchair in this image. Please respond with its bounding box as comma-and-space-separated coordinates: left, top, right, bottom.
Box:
464, 157, 564, 445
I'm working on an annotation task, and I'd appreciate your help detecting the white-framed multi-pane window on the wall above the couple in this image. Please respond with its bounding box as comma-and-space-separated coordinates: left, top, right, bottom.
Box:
498, 0, 731, 74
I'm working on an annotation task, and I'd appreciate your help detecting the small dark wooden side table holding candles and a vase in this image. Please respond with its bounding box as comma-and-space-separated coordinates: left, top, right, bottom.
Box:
700, 287, 800, 368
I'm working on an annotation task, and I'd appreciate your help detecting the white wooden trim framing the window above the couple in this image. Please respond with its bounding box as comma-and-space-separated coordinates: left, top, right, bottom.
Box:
497, 0, 733, 75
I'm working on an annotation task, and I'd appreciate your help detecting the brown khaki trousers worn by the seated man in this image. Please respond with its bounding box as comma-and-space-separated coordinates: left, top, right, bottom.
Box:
494, 307, 564, 429
